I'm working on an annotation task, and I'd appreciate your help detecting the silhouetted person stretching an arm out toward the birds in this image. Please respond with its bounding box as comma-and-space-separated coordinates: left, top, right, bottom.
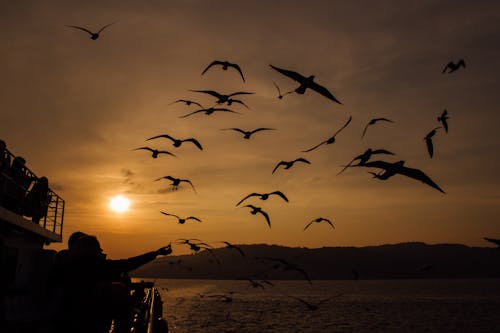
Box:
51, 235, 172, 333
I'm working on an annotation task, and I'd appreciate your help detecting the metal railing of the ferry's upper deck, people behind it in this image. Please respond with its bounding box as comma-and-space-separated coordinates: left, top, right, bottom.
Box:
0, 143, 64, 235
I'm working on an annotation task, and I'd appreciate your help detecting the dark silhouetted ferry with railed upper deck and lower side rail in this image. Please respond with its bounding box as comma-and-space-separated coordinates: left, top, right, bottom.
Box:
0, 140, 168, 333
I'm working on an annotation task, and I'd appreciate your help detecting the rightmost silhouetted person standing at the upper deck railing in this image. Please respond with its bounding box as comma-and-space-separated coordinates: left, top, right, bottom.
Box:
24, 177, 50, 224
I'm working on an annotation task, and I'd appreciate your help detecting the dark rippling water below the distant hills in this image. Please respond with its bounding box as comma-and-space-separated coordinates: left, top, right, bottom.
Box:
148, 279, 500, 333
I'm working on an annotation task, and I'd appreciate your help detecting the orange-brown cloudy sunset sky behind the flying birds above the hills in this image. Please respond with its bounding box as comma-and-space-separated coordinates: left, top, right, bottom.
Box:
0, 0, 500, 258
